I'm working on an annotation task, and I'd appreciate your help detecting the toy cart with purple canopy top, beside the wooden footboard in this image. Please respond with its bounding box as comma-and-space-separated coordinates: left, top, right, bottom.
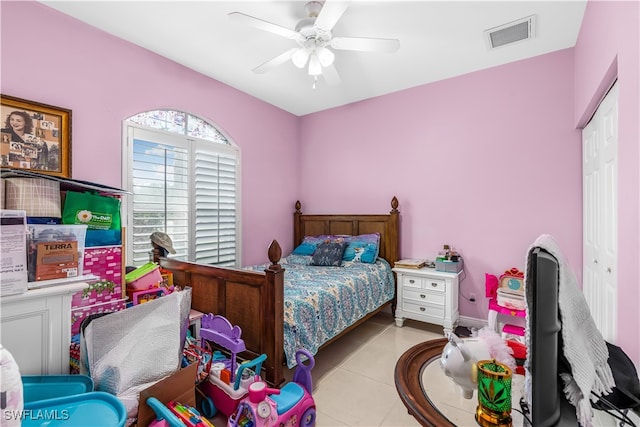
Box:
198, 314, 267, 418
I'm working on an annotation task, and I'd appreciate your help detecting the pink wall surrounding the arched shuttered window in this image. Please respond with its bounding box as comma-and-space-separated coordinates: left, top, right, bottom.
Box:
1, 1, 298, 264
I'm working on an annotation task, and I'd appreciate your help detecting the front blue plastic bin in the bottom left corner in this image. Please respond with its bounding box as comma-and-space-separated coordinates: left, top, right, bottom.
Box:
22, 391, 127, 427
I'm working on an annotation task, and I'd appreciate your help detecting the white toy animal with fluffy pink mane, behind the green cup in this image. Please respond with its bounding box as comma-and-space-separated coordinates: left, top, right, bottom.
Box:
440, 327, 516, 399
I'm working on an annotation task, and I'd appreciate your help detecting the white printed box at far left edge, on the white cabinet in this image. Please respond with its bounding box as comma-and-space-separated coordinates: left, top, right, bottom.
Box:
0, 209, 28, 296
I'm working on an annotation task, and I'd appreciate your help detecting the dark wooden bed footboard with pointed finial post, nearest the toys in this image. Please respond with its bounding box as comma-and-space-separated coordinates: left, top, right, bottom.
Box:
159, 240, 284, 386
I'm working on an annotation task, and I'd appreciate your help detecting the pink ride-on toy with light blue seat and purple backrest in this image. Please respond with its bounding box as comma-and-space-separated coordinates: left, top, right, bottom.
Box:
227, 350, 316, 427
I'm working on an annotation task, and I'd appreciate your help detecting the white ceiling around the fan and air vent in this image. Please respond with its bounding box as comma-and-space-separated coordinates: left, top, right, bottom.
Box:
41, 0, 586, 116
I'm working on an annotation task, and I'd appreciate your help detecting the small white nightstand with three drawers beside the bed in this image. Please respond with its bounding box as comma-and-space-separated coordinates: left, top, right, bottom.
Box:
393, 267, 462, 335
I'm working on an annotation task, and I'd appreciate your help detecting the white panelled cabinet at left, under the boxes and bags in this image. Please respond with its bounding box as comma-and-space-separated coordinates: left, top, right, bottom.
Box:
0, 281, 89, 375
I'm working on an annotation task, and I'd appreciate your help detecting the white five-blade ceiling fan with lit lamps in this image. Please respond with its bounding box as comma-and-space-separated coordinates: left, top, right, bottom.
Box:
229, 0, 400, 89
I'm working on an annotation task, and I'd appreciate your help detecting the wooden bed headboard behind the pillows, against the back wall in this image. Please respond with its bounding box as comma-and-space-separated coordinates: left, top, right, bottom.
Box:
293, 196, 400, 267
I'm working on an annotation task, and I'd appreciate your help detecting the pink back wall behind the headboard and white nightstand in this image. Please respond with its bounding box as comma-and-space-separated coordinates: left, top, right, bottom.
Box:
301, 49, 582, 319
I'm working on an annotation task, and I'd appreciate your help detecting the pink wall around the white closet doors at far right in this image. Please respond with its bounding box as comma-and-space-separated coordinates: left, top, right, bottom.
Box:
574, 1, 640, 366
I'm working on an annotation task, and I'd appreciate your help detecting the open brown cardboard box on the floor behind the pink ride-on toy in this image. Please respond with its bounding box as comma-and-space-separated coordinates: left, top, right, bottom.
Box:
137, 363, 198, 427
